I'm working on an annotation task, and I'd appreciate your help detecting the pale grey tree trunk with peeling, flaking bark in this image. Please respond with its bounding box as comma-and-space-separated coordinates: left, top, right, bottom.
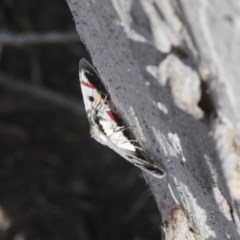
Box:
67, 0, 240, 239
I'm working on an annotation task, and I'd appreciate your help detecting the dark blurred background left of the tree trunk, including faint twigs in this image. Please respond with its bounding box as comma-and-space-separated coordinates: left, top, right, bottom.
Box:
0, 0, 161, 240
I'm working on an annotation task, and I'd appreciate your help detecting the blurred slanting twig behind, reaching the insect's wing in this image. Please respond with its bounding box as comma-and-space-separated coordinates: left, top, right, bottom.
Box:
0, 73, 85, 115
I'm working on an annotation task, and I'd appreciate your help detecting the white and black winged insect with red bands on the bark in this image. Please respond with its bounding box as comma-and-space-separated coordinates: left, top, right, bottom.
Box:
79, 59, 164, 178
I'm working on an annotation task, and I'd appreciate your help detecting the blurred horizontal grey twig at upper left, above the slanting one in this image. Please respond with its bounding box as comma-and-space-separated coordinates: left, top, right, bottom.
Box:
0, 32, 80, 46
